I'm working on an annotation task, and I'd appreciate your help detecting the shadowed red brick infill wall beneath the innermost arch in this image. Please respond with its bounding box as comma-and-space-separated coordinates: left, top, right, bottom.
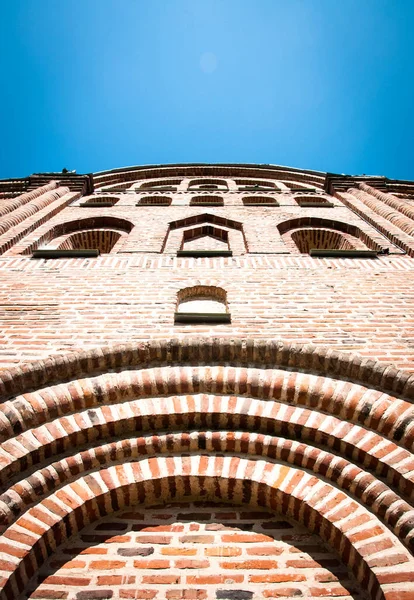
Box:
29, 502, 365, 600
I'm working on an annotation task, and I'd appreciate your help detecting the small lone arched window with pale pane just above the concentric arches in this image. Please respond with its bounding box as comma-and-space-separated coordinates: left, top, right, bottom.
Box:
174, 285, 231, 323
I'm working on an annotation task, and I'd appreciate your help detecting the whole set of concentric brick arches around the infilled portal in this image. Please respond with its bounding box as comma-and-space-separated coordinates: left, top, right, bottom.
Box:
0, 339, 414, 600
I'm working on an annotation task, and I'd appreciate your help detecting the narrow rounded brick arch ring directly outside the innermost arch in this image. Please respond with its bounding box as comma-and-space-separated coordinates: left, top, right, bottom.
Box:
0, 424, 413, 548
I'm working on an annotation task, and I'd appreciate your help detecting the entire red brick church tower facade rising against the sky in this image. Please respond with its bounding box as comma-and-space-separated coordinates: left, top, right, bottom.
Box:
0, 164, 414, 600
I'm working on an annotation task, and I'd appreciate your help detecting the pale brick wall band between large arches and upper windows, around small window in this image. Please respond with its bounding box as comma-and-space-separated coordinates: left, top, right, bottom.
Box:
0, 255, 414, 371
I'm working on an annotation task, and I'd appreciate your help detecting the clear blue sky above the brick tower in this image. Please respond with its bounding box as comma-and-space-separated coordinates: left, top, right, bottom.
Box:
0, 0, 414, 179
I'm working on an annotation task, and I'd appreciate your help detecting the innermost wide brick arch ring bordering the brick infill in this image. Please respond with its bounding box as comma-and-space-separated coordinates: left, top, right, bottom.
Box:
0, 454, 414, 600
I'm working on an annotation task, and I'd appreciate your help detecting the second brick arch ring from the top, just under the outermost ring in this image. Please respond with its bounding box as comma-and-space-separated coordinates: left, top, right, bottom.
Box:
0, 364, 414, 442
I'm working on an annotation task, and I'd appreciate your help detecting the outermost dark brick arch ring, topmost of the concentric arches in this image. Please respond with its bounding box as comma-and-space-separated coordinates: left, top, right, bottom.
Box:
0, 338, 414, 398
